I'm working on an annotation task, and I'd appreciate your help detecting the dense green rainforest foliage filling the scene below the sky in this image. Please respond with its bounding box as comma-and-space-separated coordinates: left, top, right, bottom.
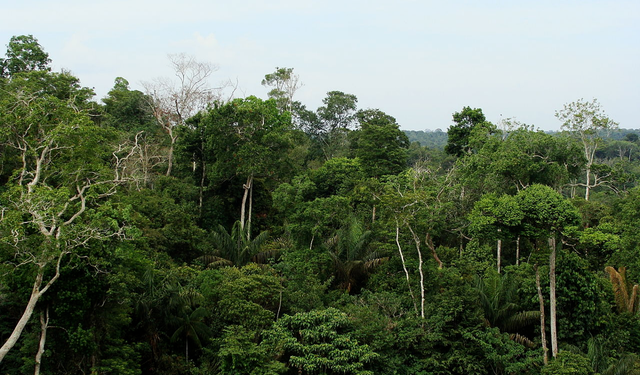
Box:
0, 36, 640, 375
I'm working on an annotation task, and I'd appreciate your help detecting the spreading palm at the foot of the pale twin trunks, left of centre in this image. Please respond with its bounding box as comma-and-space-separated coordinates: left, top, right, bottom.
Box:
199, 221, 269, 267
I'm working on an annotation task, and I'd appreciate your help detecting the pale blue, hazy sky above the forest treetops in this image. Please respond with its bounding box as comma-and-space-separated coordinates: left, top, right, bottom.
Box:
0, 0, 640, 131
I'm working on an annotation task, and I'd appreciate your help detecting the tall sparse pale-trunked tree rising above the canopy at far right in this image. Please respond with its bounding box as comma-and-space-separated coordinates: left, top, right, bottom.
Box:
556, 99, 618, 200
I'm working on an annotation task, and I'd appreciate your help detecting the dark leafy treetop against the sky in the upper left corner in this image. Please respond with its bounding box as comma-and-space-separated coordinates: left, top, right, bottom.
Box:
0, 35, 51, 77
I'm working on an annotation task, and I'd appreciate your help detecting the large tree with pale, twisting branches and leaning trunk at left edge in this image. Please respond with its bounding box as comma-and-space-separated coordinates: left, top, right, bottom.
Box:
0, 67, 124, 361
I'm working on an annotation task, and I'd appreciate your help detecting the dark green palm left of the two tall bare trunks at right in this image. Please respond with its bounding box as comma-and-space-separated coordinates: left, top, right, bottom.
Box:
473, 271, 540, 347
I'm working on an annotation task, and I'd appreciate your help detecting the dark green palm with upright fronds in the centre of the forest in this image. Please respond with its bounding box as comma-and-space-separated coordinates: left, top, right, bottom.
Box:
325, 217, 389, 293
